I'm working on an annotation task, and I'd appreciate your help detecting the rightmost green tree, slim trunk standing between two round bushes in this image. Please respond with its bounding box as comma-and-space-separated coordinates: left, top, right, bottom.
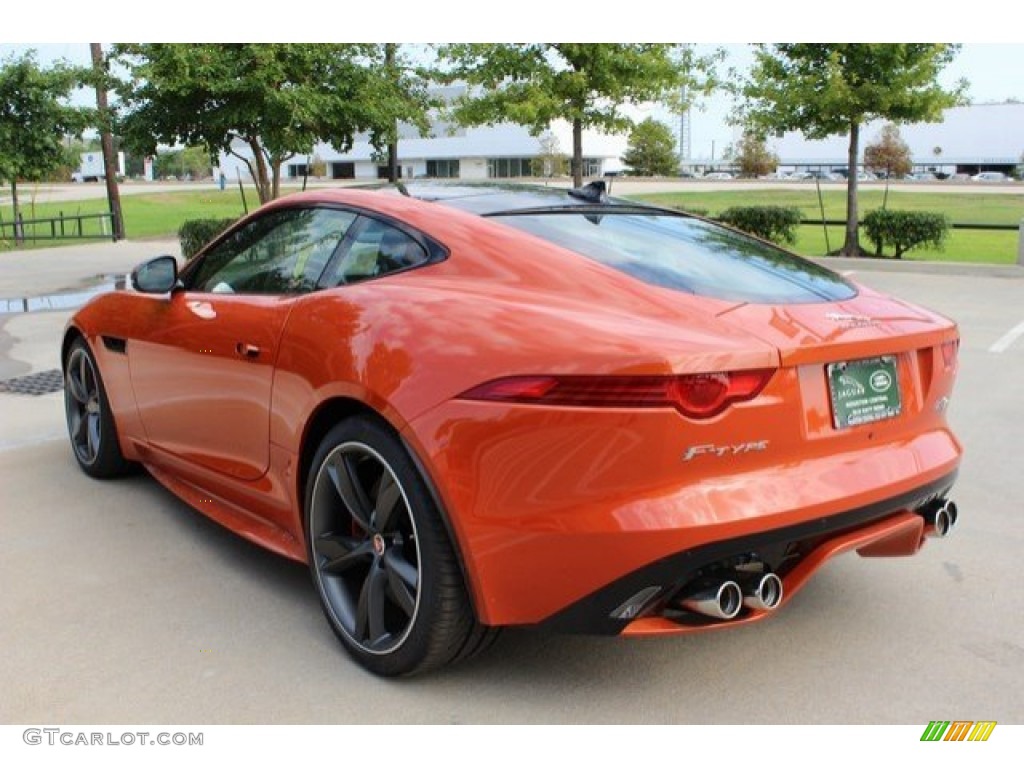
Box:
738, 43, 967, 256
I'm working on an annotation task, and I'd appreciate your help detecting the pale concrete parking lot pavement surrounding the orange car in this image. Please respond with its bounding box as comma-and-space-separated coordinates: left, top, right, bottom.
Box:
0, 244, 1024, 726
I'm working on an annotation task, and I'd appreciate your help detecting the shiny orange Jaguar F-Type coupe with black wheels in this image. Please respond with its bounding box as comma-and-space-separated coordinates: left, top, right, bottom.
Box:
61, 182, 961, 675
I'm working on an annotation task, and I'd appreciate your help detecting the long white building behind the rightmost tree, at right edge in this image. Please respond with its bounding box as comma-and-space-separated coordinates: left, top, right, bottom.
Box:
768, 103, 1024, 174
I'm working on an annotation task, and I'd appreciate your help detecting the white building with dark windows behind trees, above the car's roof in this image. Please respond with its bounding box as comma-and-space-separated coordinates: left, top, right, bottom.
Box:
220, 88, 628, 180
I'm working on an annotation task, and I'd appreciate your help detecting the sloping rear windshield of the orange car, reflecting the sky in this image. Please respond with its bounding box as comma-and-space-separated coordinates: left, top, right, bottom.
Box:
489, 214, 856, 304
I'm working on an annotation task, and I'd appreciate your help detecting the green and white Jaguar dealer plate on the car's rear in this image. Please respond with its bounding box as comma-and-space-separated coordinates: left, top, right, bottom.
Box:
825, 355, 901, 429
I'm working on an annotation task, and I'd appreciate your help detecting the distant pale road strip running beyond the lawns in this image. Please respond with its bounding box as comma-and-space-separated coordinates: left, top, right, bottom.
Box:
0, 178, 1024, 203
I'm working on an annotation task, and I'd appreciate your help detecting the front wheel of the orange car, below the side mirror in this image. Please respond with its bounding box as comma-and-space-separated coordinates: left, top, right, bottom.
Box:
65, 338, 131, 478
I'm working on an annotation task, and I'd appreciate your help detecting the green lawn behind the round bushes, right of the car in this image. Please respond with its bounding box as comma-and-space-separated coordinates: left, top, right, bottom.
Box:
635, 185, 1024, 264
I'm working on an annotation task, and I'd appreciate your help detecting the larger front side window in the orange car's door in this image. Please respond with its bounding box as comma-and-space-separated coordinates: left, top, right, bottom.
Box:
188, 208, 355, 294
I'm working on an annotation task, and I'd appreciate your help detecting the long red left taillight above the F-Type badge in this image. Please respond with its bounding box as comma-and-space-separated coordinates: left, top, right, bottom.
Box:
460, 369, 774, 419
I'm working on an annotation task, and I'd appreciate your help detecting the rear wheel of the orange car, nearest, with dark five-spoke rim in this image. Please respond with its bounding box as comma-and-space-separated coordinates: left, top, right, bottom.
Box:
305, 417, 486, 677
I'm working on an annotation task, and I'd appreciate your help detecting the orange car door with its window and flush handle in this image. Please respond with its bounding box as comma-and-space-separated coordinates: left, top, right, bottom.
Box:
128, 207, 355, 480
